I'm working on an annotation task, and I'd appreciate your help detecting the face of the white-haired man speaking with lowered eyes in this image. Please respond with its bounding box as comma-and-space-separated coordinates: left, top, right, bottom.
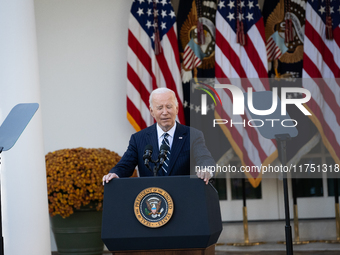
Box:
150, 92, 178, 132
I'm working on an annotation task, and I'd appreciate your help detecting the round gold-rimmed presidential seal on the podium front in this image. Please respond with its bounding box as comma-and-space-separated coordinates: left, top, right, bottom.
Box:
134, 187, 174, 228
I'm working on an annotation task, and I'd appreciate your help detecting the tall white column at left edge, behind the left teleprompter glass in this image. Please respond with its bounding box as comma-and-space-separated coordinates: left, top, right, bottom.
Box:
0, 0, 51, 255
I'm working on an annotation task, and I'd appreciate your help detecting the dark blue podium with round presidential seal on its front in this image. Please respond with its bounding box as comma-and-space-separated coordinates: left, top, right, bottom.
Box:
102, 176, 222, 255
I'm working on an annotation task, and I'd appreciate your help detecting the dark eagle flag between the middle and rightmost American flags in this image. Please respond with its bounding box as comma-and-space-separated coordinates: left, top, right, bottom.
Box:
262, 0, 320, 165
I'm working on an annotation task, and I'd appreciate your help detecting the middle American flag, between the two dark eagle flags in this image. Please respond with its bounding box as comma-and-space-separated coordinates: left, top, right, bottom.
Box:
215, 0, 277, 187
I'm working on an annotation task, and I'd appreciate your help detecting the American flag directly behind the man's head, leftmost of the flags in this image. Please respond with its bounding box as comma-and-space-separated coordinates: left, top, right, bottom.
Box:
127, 0, 184, 131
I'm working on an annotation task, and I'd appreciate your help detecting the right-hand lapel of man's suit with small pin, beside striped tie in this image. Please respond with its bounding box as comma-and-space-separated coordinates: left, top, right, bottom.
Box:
167, 123, 189, 175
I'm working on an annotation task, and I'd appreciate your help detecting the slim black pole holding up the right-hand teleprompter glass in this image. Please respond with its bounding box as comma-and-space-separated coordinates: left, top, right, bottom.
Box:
275, 134, 293, 255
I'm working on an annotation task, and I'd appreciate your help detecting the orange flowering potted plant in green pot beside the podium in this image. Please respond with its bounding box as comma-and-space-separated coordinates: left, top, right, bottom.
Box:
45, 148, 121, 255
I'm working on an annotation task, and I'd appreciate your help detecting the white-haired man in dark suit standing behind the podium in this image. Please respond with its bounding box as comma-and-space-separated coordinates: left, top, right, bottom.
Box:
103, 88, 215, 184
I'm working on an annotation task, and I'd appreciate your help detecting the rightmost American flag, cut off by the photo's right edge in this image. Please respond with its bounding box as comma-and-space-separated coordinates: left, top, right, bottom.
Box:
302, 0, 340, 164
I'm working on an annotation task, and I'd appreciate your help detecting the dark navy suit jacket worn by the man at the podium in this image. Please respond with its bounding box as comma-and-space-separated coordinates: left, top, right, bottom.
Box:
110, 123, 216, 177
